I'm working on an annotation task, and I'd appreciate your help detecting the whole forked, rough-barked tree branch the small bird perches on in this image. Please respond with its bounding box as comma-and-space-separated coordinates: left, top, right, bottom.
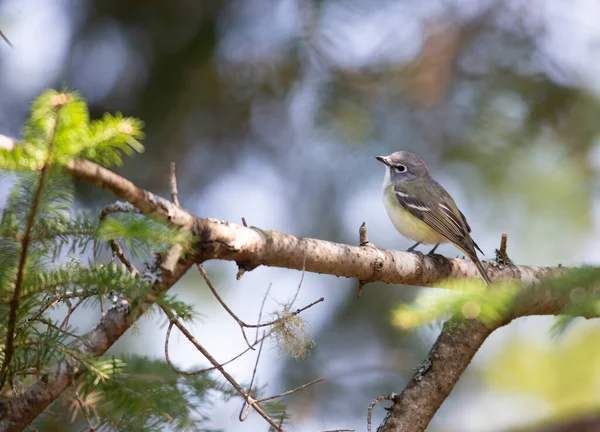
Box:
0, 135, 568, 431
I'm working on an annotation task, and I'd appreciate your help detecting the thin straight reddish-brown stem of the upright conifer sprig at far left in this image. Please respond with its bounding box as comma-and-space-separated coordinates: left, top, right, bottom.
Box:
0, 105, 62, 389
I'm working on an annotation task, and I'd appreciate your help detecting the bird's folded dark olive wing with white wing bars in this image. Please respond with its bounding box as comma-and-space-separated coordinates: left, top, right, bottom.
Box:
394, 180, 479, 257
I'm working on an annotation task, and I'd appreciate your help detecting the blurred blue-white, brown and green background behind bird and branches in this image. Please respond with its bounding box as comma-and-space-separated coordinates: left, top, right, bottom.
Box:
0, 0, 600, 432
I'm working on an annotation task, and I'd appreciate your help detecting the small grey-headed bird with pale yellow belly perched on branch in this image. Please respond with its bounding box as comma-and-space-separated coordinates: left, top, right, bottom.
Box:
375, 151, 491, 284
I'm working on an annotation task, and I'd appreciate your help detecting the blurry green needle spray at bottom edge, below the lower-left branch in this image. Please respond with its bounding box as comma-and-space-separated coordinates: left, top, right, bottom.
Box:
36, 356, 234, 432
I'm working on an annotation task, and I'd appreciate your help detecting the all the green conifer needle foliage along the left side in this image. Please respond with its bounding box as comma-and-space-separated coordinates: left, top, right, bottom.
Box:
0, 91, 225, 431
